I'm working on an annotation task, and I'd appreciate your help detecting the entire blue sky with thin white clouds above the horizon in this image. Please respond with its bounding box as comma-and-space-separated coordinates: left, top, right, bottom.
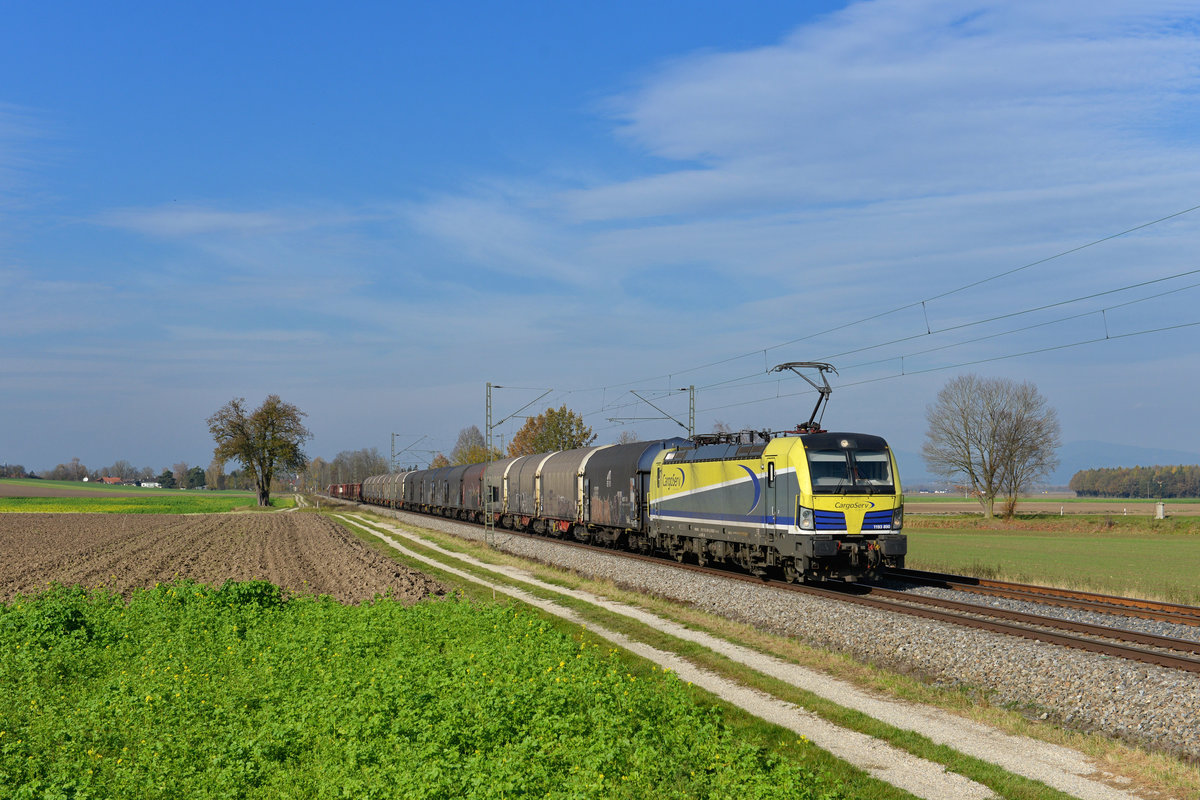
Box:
0, 0, 1200, 469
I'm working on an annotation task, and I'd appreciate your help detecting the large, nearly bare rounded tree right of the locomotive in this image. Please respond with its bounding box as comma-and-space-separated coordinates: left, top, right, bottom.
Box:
923, 374, 1061, 519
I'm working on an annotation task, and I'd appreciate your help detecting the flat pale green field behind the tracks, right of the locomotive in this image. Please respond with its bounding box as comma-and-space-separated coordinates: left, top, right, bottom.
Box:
905, 516, 1200, 604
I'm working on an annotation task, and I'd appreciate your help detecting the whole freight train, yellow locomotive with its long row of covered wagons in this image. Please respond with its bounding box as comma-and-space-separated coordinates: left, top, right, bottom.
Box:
329, 429, 907, 582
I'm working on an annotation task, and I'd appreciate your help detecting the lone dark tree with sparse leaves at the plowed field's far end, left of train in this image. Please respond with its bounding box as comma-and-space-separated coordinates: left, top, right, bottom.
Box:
208, 395, 312, 506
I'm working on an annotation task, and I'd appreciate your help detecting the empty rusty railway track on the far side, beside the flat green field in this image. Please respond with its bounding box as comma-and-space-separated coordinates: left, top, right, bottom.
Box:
884, 570, 1200, 627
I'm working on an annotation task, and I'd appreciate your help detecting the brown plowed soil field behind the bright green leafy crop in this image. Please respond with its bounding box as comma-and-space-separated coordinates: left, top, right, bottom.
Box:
0, 513, 445, 603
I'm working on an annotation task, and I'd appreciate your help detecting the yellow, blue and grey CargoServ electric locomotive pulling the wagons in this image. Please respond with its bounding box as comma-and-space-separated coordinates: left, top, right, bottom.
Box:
647, 432, 907, 582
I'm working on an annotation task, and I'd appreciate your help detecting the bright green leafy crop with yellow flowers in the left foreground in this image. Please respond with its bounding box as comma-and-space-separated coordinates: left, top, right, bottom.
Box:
0, 582, 839, 798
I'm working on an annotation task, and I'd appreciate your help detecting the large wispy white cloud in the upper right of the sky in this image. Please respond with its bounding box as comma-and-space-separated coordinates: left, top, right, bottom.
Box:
563, 0, 1200, 221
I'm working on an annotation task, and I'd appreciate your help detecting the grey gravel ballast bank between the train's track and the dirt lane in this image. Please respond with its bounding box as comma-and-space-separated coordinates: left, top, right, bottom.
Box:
371, 507, 1200, 759
